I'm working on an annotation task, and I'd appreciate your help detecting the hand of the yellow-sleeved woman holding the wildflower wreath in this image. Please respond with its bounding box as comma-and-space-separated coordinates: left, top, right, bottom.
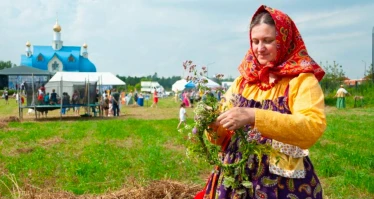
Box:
217, 107, 255, 130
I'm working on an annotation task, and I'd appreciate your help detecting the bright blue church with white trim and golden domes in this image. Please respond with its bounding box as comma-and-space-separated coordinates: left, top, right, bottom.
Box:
20, 20, 96, 73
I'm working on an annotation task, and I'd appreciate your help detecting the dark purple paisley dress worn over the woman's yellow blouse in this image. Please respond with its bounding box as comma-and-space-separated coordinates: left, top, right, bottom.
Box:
204, 93, 323, 199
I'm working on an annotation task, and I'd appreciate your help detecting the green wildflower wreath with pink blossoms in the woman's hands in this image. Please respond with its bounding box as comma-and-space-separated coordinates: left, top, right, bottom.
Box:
182, 60, 272, 190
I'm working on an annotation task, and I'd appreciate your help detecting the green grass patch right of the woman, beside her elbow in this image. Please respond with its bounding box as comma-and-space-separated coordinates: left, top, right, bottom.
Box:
310, 108, 374, 198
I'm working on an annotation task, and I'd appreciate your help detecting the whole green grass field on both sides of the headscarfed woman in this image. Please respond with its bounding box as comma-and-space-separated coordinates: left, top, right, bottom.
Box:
0, 95, 374, 199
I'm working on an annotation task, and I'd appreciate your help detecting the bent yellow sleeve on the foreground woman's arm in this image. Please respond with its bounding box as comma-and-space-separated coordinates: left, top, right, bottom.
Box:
255, 73, 326, 149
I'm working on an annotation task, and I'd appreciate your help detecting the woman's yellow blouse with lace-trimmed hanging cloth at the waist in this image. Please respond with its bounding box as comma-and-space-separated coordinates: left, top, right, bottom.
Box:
215, 73, 326, 178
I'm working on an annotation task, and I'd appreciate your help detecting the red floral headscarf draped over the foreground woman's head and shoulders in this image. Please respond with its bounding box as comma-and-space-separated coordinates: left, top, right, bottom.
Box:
239, 5, 325, 83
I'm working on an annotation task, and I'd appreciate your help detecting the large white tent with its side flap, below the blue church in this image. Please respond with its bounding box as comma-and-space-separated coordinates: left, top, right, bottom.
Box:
45, 72, 126, 95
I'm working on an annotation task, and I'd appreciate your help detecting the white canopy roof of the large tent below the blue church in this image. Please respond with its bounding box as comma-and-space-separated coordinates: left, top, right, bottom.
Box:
48, 72, 126, 85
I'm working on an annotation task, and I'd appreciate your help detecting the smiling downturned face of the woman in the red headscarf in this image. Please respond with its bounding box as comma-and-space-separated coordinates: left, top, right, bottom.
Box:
251, 23, 277, 65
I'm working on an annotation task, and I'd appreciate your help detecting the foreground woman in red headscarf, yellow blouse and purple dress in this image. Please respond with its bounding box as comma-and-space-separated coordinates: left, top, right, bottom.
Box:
200, 6, 326, 198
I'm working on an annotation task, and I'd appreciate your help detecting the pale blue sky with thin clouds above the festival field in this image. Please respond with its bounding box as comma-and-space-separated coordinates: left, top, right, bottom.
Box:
0, 0, 374, 79
